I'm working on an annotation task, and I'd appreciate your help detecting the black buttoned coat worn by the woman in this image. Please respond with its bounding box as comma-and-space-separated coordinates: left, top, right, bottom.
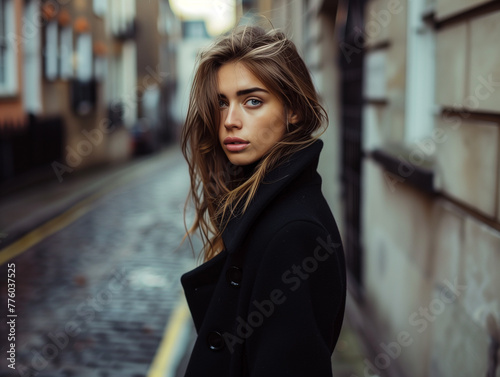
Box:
181, 140, 346, 377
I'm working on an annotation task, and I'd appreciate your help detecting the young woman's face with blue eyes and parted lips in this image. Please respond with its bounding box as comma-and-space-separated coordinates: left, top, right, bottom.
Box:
218, 63, 286, 165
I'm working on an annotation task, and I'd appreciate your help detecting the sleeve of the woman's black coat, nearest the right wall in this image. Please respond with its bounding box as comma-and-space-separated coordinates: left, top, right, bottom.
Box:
245, 221, 346, 377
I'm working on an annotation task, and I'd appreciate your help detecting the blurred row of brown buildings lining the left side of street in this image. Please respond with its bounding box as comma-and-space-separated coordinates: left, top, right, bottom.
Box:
0, 0, 180, 186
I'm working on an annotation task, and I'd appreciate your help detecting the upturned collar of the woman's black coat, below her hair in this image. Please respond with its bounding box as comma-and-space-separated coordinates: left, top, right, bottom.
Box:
222, 139, 323, 253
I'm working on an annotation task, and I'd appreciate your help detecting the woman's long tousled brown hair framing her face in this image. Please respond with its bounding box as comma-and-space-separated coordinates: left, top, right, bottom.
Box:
181, 26, 328, 261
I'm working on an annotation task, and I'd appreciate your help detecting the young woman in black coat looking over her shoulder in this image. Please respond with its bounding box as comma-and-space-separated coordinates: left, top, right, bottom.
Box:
181, 26, 346, 377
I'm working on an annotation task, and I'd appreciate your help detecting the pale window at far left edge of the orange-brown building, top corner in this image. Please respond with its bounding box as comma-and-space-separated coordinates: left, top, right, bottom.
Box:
0, 0, 17, 96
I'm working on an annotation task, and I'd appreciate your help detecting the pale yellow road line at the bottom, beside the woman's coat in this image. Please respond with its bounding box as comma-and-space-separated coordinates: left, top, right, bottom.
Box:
147, 299, 190, 377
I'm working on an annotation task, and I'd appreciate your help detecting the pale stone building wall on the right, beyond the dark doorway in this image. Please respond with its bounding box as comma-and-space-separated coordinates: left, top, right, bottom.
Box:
362, 0, 500, 376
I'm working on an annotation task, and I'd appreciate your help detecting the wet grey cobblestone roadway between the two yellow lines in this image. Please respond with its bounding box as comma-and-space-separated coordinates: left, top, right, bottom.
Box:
0, 150, 197, 377
